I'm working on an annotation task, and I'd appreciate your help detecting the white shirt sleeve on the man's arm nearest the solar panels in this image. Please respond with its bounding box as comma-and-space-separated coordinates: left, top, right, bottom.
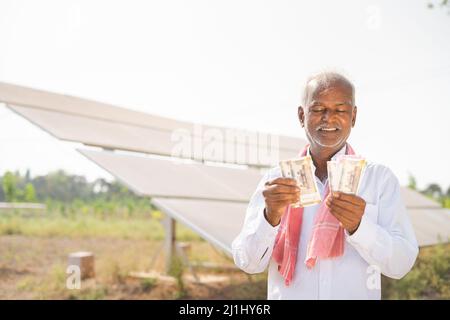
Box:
231, 171, 279, 273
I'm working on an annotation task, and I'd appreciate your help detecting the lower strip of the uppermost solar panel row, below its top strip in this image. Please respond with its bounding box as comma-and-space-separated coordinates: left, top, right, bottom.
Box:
9, 105, 305, 166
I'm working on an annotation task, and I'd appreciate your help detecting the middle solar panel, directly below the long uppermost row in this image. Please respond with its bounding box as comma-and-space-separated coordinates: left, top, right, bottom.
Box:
78, 150, 261, 202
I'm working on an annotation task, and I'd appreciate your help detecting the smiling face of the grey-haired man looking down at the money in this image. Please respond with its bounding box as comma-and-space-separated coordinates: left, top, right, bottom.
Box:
299, 80, 357, 151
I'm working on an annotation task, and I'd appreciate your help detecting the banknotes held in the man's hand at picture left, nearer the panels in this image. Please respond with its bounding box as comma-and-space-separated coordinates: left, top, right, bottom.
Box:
280, 156, 321, 207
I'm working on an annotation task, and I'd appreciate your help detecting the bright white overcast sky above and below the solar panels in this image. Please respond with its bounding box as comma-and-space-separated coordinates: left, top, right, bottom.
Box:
0, 0, 450, 189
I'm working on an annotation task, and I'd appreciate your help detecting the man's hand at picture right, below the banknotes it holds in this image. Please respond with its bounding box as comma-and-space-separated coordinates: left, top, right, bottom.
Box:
326, 192, 366, 234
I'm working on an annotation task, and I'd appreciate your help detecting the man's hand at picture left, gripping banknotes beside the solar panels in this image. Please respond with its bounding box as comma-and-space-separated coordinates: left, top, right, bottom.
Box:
262, 178, 300, 226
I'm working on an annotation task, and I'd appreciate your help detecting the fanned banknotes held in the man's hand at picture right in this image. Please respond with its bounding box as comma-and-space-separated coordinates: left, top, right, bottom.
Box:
327, 156, 367, 194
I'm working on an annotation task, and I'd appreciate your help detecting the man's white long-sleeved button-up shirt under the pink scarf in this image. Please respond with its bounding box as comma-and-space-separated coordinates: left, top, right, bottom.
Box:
232, 148, 419, 299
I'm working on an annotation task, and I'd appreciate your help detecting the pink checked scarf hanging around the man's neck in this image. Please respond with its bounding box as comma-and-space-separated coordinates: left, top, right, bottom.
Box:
272, 144, 355, 286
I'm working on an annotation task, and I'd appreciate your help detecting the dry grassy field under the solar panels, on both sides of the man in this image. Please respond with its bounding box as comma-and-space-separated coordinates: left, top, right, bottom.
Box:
0, 206, 450, 299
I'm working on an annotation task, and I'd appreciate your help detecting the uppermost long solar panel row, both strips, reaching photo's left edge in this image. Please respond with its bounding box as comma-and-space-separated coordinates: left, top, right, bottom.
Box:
0, 82, 306, 166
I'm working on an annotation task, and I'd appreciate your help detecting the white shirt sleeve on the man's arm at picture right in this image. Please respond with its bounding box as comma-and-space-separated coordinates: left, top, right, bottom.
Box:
346, 169, 419, 279
